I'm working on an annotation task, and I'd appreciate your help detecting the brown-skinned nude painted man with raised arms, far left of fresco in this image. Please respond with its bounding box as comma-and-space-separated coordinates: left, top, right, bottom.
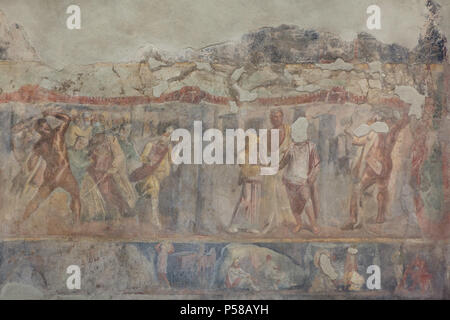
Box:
20, 110, 81, 225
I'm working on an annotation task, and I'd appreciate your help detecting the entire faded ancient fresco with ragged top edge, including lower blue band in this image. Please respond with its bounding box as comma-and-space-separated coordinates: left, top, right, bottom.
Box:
0, 1, 450, 299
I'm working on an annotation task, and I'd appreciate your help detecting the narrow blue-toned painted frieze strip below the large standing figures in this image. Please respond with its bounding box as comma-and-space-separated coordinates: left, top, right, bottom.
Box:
0, 240, 450, 299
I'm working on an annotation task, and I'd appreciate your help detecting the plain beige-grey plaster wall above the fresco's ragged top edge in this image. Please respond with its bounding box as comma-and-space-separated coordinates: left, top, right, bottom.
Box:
1, 0, 450, 68
